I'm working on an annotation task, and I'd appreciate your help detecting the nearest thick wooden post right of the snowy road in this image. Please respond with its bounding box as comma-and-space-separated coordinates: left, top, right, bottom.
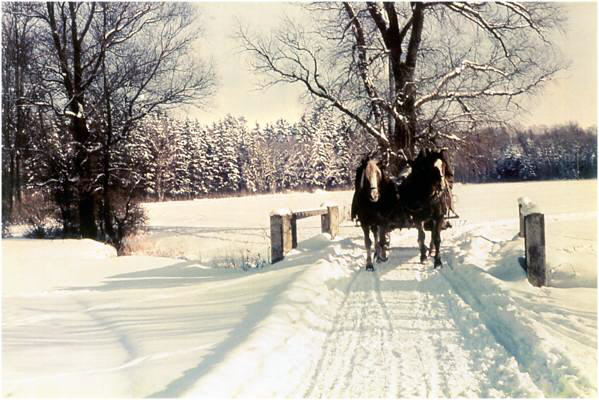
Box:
524, 213, 546, 286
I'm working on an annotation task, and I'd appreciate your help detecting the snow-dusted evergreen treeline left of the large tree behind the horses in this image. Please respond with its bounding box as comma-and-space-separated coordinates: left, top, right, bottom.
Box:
119, 111, 374, 200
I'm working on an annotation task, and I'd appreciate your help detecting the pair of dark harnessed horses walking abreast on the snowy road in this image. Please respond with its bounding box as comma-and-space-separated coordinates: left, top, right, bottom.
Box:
351, 150, 453, 270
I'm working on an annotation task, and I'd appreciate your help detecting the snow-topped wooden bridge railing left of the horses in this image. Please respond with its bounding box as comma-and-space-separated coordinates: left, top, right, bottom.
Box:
270, 204, 340, 264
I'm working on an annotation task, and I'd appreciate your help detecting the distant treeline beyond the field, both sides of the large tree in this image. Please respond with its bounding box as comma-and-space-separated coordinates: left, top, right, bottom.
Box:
122, 110, 597, 200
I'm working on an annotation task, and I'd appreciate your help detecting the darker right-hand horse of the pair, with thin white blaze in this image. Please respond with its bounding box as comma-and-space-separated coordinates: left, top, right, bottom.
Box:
397, 149, 453, 268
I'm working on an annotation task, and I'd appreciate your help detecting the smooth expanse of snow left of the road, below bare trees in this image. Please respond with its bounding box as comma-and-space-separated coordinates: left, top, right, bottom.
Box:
2, 240, 302, 398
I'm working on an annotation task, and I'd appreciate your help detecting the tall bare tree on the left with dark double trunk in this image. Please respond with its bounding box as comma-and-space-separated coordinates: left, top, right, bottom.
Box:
25, 2, 214, 237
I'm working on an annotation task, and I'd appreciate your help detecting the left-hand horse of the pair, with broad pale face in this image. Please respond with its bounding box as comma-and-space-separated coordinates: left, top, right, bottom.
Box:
351, 154, 397, 271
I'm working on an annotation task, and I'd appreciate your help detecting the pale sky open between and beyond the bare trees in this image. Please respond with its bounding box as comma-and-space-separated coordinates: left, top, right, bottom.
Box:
185, 2, 597, 128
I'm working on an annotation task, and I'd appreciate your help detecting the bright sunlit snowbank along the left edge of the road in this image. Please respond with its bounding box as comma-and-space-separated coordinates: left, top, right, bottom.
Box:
183, 235, 355, 398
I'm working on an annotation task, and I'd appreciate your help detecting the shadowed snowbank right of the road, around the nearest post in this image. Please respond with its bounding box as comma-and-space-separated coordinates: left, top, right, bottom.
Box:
442, 225, 597, 397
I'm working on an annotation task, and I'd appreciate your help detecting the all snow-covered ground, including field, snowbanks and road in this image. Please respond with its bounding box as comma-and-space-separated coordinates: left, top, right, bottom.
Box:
2, 181, 597, 397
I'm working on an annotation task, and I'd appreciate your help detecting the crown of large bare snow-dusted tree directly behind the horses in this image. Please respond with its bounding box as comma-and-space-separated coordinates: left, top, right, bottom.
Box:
238, 2, 564, 166
